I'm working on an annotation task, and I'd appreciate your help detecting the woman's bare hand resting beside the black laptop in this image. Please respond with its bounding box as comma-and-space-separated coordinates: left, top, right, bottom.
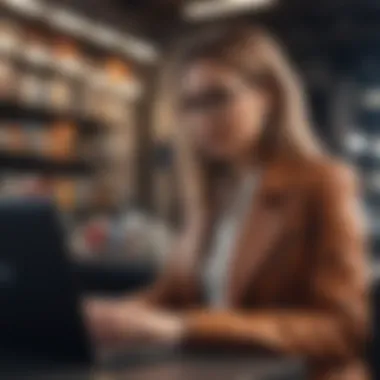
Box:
84, 299, 184, 346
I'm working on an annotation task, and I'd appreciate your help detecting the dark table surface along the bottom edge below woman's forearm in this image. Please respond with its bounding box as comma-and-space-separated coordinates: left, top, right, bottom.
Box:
6, 357, 303, 380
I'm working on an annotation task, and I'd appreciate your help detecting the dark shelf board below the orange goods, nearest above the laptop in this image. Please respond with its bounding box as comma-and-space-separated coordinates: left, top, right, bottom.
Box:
0, 152, 92, 176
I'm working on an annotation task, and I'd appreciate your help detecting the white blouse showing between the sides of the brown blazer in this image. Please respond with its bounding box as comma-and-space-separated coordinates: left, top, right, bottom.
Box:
202, 172, 258, 309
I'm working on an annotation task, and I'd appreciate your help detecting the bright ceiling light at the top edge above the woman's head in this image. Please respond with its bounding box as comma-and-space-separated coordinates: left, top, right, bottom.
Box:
183, 0, 276, 21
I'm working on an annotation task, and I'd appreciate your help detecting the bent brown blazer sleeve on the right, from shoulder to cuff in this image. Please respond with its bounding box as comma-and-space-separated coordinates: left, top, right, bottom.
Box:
185, 165, 369, 358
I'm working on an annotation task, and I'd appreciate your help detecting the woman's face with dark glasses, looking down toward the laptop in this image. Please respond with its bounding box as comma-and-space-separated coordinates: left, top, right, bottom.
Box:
180, 60, 270, 161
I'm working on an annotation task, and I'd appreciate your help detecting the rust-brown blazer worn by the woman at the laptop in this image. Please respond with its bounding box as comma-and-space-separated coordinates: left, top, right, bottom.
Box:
137, 157, 369, 380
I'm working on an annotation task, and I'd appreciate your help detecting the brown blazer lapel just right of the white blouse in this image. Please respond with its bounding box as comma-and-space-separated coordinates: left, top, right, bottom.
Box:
228, 168, 285, 307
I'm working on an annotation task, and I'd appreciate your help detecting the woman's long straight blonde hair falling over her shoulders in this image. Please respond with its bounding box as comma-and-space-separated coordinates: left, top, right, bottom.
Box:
157, 26, 322, 235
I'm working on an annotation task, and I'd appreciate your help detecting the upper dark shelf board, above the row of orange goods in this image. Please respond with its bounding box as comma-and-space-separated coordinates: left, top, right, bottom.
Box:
0, 99, 102, 133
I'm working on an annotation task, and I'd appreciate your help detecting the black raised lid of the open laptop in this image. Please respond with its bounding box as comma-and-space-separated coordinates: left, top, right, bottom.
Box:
0, 199, 94, 368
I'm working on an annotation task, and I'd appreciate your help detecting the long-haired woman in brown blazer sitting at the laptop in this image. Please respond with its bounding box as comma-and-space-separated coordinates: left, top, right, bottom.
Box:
87, 28, 368, 380
